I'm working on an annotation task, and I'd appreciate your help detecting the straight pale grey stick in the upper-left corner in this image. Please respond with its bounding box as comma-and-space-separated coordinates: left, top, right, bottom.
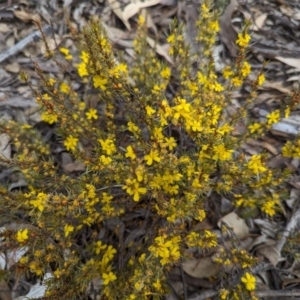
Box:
0, 25, 52, 63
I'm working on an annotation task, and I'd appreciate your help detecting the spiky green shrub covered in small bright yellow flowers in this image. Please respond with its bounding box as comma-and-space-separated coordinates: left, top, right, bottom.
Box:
0, 1, 299, 299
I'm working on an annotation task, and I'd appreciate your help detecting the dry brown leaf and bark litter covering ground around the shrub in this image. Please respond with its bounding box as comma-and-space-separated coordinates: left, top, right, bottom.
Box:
0, 0, 300, 300
